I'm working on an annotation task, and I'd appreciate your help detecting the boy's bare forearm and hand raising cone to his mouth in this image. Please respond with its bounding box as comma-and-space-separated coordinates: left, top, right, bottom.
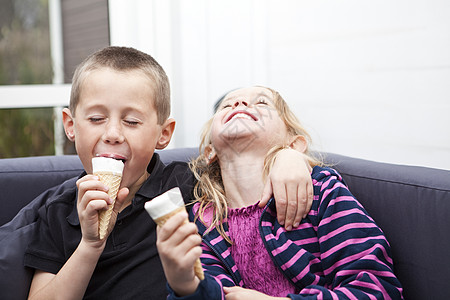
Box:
28, 175, 128, 299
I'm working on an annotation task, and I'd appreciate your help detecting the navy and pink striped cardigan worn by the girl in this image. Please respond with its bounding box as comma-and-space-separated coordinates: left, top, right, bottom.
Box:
169, 167, 402, 299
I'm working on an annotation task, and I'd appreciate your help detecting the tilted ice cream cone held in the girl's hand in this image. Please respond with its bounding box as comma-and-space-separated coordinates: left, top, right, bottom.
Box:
145, 188, 205, 280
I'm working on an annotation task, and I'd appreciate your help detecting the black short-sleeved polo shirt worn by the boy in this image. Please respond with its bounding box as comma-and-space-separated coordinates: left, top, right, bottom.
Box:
24, 153, 194, 299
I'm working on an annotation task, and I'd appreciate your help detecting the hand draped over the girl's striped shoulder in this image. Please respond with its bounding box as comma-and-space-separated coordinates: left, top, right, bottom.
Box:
259, 149, 313, 230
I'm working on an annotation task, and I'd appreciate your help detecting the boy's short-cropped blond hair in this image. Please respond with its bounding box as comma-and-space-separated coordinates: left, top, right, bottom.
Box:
69, 46, 170, 125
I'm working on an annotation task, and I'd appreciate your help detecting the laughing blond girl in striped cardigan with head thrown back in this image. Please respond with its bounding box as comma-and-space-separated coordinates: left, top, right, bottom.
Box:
157, 87, 402, 299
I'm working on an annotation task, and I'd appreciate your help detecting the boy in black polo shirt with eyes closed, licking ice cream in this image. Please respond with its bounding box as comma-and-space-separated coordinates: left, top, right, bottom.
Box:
25, 47, 309, 299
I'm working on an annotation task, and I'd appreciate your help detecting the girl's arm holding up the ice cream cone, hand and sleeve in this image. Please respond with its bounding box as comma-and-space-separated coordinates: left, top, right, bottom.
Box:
156, 206, 235, 300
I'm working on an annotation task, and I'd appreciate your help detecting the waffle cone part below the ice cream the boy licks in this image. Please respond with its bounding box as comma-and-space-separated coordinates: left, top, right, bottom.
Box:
95, 173, 122, 239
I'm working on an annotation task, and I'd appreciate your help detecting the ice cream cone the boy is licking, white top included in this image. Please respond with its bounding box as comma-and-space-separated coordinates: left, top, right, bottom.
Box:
92, 157, 123, 239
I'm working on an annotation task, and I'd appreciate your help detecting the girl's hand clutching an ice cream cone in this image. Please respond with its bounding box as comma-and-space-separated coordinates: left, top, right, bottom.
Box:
156, 212, 202, 296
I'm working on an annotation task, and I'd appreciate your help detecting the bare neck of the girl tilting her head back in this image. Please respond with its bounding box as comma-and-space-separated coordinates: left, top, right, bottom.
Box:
219, 152, 264, 208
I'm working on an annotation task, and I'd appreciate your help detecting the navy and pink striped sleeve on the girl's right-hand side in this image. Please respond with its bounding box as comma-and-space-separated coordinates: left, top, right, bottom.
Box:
290, 168, 402, 299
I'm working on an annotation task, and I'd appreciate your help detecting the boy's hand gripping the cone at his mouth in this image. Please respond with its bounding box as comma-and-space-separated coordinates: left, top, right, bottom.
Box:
77, 175, 129, 246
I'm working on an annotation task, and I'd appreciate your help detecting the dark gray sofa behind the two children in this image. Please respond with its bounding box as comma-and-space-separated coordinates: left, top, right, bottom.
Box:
0, 148, 450, 300
